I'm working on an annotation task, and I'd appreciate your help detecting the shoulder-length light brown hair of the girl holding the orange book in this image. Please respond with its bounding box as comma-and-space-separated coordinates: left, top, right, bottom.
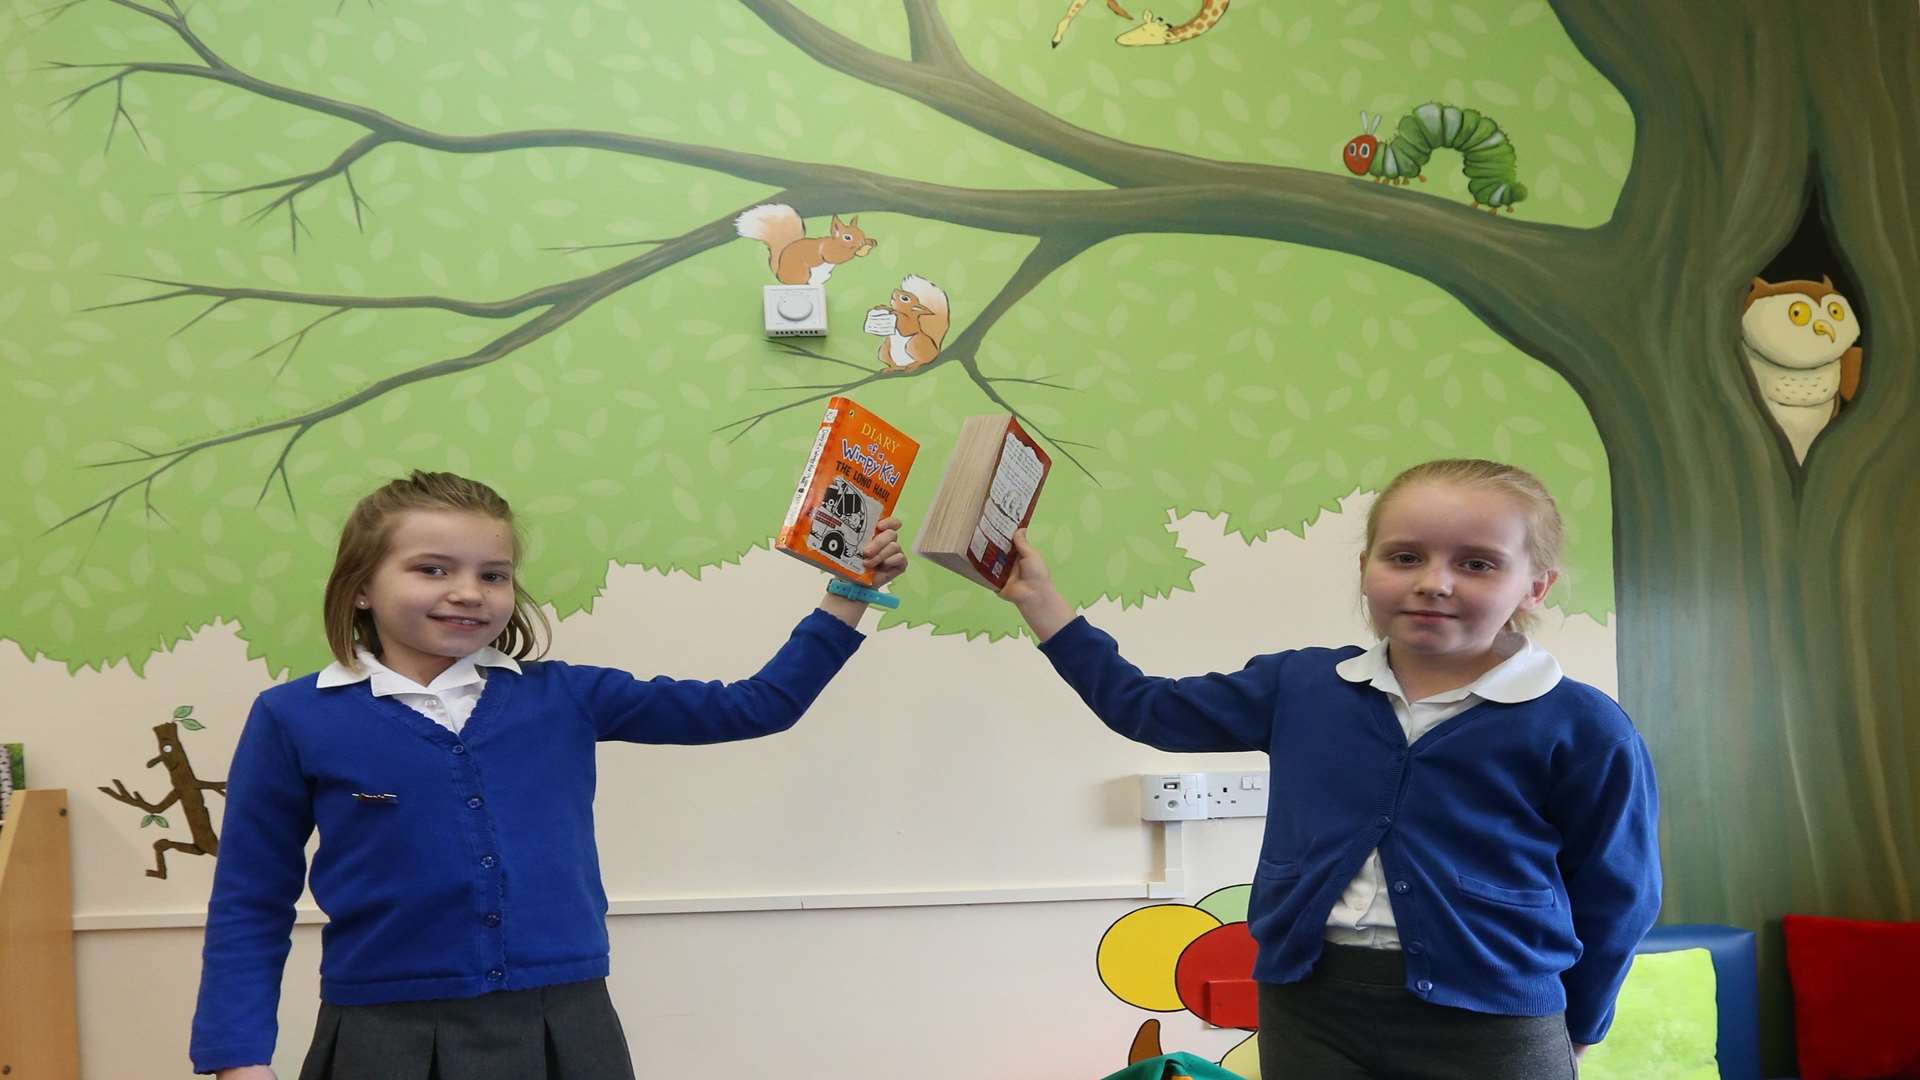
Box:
321, 469, 553, 667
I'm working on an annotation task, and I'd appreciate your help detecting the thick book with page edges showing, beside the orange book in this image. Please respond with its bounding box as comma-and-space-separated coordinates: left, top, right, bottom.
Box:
916, 415, 1052, 590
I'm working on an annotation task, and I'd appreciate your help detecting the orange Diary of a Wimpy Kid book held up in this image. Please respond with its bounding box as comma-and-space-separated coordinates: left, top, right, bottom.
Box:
774, 398, 920, 586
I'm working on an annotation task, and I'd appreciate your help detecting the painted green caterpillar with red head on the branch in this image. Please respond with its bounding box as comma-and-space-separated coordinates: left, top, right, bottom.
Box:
1340, 102, 1526, 213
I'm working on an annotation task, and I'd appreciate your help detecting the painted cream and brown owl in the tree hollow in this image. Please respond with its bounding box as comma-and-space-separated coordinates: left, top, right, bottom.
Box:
1740, 277, 1860, 461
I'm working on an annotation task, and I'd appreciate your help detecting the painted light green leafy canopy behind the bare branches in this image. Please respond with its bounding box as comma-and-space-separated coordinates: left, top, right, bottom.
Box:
0, 0, 1632, 672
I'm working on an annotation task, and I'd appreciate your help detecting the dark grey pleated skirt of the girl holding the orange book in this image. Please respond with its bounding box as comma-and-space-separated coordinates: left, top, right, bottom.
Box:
300, 978, 634, 1080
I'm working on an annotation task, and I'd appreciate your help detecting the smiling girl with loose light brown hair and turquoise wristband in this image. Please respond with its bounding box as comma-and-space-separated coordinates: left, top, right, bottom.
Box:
190, 473, 906, 1080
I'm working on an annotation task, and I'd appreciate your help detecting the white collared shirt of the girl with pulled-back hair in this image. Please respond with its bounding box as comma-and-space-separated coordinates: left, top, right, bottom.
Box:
1325, 632, 1561, 949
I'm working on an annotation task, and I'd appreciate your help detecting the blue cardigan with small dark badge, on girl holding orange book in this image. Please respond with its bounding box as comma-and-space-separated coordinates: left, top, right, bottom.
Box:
190, 611, 862, 1072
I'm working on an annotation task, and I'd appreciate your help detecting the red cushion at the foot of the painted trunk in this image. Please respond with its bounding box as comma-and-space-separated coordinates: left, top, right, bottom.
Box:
1782, 915, 1920, 1080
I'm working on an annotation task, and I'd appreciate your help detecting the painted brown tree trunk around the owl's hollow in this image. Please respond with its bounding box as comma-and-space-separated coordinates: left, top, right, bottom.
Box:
1542, 2, 1920, 1074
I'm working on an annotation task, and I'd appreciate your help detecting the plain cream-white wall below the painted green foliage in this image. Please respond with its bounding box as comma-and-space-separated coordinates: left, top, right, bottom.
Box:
0, 498, 1615, 1080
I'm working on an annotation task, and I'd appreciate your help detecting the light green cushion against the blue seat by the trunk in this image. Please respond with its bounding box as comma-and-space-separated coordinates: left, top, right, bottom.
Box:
1580, 949, 1720, 1080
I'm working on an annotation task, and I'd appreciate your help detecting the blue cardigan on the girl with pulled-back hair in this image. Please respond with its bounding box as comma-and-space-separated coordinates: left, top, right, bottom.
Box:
1041, 619, 1661, 1043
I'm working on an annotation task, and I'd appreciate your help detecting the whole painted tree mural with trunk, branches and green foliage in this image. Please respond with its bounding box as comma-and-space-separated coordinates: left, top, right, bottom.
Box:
0, 0, 1920, 1067
